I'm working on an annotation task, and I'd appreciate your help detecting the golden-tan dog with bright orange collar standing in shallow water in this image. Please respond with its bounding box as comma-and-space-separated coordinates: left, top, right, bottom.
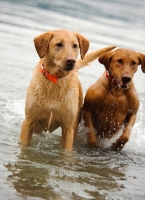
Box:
20, 30, 114, 151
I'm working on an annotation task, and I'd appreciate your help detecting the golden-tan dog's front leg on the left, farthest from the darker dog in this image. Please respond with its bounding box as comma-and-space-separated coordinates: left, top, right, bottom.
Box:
20, 119, 34, 145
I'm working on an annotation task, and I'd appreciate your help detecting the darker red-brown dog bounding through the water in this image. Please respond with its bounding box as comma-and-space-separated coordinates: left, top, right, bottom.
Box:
83, 49, 145, 150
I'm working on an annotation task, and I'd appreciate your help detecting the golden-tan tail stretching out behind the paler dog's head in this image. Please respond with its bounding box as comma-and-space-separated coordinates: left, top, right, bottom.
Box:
76, 46, 116, 69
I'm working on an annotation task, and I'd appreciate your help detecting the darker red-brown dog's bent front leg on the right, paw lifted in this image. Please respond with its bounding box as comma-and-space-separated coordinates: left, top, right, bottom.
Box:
111, 115, 136, 151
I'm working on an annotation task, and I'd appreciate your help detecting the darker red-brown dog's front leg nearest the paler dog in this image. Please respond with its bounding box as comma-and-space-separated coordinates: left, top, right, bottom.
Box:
83, 108, 97, 146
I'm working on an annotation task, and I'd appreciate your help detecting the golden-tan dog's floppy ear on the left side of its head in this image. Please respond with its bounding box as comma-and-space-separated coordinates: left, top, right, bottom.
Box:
34, 31, 53, 58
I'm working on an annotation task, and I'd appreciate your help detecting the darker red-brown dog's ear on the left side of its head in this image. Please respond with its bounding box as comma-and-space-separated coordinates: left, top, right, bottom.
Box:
98, 51, 114, 70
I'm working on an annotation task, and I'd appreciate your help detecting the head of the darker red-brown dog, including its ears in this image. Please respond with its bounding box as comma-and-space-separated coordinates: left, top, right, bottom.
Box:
98, 48, 145, 89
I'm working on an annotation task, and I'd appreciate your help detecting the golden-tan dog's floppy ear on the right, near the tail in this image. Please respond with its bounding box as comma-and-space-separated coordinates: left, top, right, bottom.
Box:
77, 33, 89, 59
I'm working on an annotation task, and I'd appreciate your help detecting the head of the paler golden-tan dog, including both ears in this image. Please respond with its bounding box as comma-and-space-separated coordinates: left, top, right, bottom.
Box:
34, 30, 89, 72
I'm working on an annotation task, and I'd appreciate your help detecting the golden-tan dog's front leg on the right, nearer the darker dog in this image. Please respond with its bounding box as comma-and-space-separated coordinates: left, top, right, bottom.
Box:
61, 128, 74, 151
